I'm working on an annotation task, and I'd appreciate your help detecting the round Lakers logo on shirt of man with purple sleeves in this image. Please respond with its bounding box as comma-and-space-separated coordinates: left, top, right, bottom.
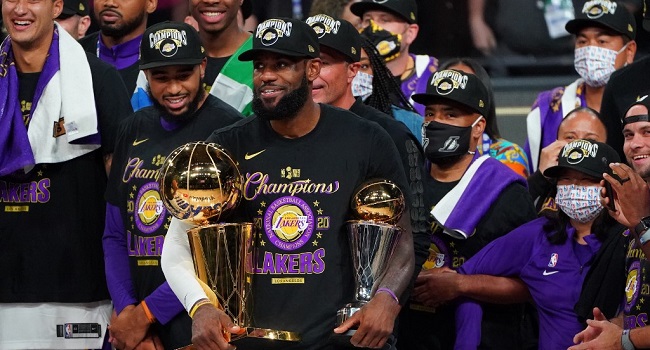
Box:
134, 182, 165, 233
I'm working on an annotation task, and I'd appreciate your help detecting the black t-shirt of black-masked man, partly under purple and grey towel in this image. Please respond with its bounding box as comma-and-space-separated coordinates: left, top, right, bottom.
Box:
397, 167, 536, 350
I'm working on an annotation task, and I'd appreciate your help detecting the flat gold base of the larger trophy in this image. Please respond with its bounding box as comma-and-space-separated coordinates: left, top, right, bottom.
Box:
177, 327, 300, 350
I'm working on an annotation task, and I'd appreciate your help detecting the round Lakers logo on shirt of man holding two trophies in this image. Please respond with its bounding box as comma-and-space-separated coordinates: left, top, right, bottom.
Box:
264, 196, 314, 250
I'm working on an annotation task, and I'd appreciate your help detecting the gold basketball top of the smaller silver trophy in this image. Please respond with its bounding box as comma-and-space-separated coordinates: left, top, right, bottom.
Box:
350, 179, 405, 225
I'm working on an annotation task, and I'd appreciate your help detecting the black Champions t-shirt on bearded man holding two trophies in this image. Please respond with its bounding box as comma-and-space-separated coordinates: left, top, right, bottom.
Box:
208, 105, 407, 350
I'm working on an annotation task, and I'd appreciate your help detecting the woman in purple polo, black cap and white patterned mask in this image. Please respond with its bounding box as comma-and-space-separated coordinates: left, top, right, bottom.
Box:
413, 140, 627, 349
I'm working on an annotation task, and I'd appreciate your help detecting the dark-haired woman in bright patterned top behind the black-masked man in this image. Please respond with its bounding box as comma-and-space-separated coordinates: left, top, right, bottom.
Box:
440, 58, 529, 178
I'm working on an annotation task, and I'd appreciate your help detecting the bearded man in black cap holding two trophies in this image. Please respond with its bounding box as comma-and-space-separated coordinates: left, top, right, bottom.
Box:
162, 19, 414, 350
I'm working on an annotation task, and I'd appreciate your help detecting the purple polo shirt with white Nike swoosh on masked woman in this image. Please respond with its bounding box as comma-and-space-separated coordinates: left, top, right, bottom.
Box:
456, 218, 601, 349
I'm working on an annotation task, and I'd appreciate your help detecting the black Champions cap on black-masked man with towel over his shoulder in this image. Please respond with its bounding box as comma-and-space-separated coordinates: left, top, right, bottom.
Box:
411, 69, 489, 117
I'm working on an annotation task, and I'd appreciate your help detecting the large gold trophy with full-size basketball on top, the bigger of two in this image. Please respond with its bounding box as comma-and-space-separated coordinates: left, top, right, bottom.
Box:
158, 141, 300, 349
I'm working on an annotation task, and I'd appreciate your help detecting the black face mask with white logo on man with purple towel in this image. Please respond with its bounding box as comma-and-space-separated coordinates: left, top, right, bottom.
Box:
422, 116, 483, 164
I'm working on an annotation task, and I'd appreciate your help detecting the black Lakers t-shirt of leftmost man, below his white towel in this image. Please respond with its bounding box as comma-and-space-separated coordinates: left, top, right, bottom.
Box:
0, 55, 132, 303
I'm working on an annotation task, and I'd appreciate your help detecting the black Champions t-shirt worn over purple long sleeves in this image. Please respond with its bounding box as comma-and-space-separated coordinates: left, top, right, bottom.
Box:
106, 95, 242, 349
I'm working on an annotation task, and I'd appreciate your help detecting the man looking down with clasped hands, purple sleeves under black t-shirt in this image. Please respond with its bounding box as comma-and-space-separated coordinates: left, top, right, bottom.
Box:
103, 22, 242, 349
